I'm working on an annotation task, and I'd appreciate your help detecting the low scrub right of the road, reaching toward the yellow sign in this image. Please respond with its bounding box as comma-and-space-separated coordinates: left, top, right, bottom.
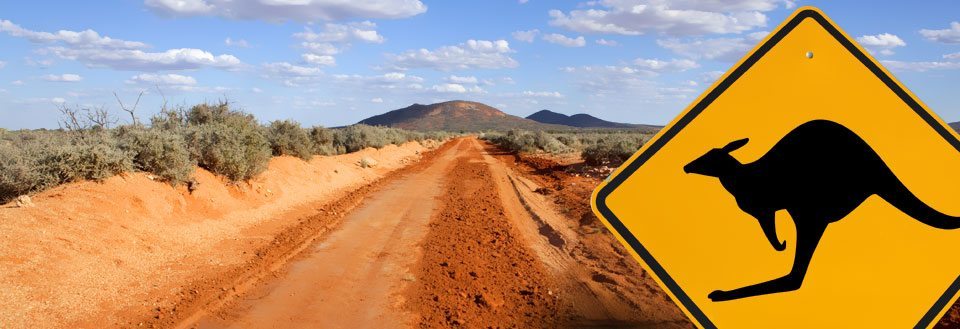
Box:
483, 130, 653, 166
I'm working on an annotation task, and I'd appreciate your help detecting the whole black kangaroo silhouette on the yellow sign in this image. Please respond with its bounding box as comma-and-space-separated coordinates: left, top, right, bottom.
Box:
683, 120, 960, 302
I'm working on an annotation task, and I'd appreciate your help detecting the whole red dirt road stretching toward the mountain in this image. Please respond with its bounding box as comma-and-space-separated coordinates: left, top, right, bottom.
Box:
178, 138, 690, 328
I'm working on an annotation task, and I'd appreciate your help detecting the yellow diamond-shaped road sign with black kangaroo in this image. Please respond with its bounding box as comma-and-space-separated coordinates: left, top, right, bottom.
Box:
593, 7, 960, 328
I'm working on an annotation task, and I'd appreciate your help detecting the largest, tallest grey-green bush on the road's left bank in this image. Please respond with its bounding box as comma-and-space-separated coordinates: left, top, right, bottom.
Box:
185, 103, 271, 181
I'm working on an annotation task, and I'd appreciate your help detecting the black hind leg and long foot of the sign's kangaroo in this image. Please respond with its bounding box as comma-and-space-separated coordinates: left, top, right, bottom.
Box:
707, 218, 827, 302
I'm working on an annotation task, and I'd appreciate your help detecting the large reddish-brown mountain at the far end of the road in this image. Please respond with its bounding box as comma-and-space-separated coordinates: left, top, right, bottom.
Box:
358, 101, 571, 131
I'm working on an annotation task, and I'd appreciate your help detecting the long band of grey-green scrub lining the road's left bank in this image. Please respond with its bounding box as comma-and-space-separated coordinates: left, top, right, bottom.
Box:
0, 101, 453, 202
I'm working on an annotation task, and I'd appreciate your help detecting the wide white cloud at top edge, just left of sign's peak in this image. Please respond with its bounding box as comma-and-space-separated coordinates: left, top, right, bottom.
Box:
549, 0, 789, 36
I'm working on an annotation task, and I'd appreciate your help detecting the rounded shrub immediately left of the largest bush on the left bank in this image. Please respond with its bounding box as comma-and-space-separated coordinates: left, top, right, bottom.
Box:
118, 126, 194, 185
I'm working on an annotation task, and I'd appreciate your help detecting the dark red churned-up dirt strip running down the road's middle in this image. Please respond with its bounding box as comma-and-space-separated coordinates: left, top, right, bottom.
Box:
409, 140, 562, 328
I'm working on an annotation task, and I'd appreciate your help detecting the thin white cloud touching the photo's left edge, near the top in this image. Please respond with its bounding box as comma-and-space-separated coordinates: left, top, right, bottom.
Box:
0, 20, 147, 49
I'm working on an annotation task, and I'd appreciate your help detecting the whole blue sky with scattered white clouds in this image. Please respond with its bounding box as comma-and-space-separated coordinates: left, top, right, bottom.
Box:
0, 0, 960, 129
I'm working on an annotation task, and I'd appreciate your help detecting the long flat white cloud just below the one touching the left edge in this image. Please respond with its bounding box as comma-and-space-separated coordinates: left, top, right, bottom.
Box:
44, 47, 241, 71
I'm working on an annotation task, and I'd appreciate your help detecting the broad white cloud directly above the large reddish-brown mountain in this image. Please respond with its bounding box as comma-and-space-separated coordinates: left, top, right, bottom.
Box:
387, 40, 519, 71
